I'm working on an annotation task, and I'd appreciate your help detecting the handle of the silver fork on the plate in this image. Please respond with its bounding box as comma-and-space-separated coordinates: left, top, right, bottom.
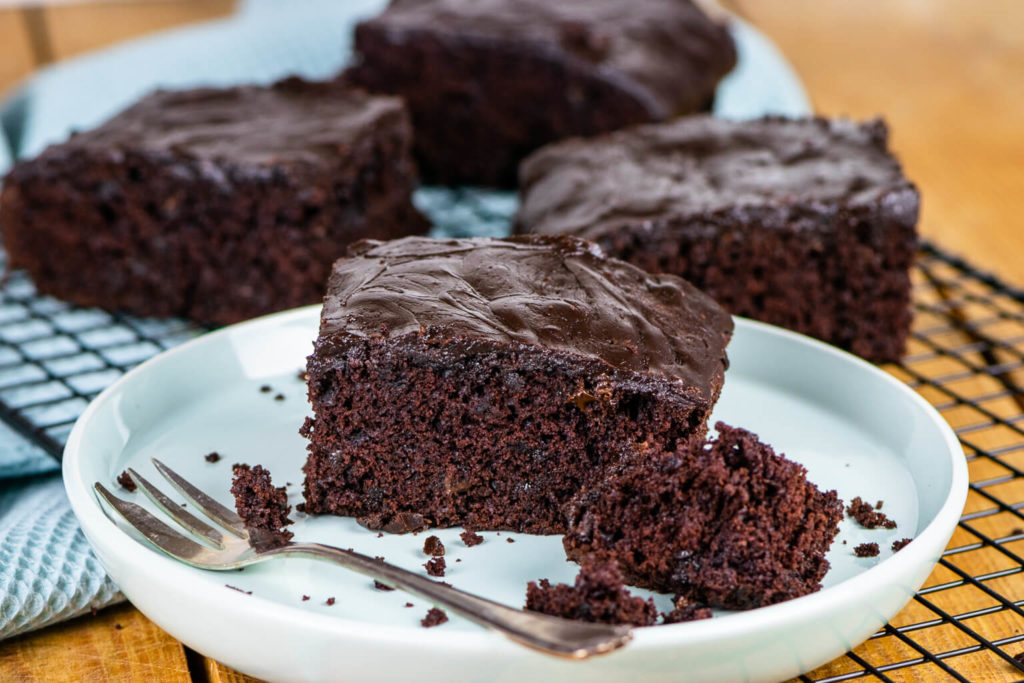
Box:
260, 543, 633, 659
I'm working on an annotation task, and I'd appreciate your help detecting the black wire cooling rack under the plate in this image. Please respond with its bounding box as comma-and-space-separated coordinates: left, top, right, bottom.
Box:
0, 233, 1024, 683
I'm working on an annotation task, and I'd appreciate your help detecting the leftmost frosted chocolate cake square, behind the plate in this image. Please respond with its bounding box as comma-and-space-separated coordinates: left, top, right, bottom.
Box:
0, 79, 426, 324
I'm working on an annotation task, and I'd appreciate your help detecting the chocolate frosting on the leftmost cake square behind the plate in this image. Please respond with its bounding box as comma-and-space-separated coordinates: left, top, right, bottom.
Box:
47, 78, 408, 172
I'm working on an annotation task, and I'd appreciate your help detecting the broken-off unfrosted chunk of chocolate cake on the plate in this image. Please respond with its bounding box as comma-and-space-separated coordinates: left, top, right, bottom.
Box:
563, 423, 843, 609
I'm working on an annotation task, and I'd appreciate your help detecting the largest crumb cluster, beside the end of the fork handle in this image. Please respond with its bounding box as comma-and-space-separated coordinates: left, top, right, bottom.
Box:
525, 561, 657, 626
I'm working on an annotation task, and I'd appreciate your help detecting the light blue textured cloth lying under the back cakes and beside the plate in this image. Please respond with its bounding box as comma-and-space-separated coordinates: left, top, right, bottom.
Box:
0, 0, 809, 638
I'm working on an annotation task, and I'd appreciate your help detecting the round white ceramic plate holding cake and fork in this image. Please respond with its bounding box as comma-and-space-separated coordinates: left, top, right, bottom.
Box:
63, 307, 967, 683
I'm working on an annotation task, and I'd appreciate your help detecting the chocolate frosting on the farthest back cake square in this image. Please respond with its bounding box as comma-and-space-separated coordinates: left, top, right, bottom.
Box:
356, 0, 736, 120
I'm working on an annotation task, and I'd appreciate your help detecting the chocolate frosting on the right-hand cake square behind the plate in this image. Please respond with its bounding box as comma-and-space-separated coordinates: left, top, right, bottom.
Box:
518, 116, 916, 240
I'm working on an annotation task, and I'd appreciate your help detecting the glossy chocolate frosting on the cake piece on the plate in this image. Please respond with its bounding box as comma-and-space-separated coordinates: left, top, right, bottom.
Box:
321, 236, 732, 399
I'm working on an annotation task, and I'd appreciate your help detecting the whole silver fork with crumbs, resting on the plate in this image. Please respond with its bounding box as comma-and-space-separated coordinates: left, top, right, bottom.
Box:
95, 458, 633, 659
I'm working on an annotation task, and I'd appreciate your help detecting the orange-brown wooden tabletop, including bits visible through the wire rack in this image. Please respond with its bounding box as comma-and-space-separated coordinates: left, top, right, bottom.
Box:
0, 0, 1024, 683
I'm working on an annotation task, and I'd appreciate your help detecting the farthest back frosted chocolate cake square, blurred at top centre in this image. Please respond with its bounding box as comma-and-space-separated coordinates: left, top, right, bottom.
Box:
346, 0, 736, 186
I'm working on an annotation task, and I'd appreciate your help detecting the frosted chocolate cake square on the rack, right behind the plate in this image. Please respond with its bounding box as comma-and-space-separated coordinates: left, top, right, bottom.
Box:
517, 117, 919, 361
